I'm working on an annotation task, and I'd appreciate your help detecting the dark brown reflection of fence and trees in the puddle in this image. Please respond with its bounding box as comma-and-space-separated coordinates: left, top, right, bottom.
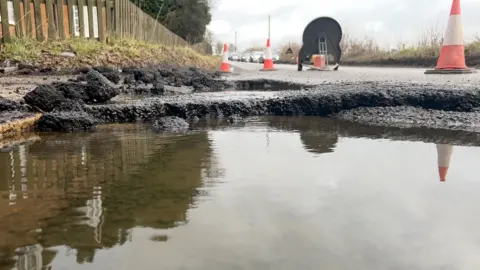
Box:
0, 126, 221, 269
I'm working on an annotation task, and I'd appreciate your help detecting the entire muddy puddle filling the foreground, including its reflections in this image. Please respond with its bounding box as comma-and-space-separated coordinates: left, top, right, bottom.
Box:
0, 118, 480, 270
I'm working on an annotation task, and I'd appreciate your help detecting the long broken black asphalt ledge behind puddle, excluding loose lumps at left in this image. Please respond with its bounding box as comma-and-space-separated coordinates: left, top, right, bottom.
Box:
86, 83, 480, 122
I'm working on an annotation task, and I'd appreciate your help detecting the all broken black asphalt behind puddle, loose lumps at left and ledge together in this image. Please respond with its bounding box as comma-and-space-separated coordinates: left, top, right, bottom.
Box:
11, 74, 480, 131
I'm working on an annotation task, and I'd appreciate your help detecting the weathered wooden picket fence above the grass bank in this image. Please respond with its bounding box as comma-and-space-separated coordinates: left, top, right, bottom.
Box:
0, 0, 188, 46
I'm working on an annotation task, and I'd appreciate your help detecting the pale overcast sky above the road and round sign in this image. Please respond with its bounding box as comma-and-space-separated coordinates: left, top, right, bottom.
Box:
207, 0, 480, 49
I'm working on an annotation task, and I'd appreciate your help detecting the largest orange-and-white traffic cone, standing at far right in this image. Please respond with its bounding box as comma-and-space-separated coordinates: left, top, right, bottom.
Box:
425, 0, 474, 74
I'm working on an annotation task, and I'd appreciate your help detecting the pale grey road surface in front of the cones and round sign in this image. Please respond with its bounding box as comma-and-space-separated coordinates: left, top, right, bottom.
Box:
230, 61, 480, 86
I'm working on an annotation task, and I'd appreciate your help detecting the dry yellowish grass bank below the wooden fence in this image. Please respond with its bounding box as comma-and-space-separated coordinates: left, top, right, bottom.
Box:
0, 38, 220, 69
